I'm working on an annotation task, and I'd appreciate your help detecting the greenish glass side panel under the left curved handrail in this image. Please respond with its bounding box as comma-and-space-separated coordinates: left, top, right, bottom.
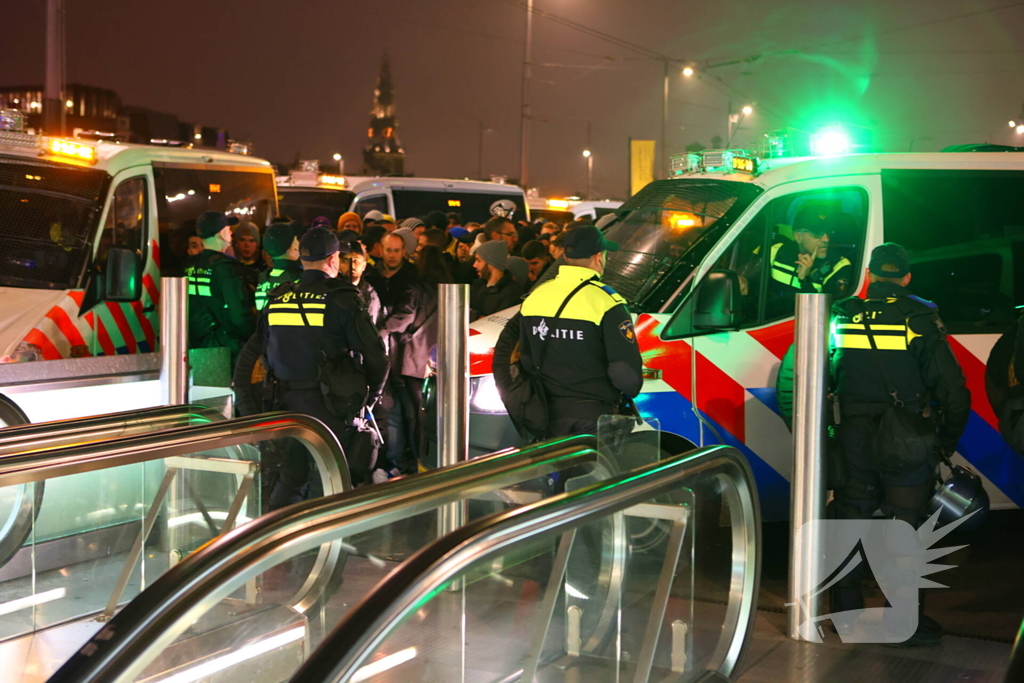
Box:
0, 430, 299, 680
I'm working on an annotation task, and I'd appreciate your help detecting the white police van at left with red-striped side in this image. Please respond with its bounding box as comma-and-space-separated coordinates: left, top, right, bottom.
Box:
0, 111, 278, 421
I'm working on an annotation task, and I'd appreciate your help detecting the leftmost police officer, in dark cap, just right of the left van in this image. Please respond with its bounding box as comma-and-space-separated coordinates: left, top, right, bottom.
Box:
184, 211, 256, 368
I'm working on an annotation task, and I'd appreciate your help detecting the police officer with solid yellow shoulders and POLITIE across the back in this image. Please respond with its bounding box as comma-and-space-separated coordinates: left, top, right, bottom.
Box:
519, 225, 643, 437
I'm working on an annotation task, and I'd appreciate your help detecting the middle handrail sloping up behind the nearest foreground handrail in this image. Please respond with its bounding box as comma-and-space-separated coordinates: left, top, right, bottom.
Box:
49, 435, 606, 683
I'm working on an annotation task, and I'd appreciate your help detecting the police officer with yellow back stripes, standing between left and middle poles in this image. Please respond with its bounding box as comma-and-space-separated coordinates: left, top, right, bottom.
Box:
258, 227, 388, 499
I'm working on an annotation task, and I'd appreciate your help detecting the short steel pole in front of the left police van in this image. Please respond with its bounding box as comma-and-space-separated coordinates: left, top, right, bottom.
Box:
160, 278, 188, 405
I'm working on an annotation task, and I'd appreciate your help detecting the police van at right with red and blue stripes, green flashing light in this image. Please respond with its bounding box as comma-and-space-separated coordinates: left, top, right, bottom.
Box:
469, 140, 1024, 519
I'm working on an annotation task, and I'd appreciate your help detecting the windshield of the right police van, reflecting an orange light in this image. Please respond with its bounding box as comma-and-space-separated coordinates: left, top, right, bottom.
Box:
603, 178, 761, 312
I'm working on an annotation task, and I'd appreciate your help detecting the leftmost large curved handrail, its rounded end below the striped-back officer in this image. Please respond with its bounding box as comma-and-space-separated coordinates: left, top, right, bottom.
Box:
0, 413, 352, 495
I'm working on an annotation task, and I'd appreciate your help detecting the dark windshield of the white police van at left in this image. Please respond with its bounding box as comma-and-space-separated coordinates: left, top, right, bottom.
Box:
0, 157, 109, 290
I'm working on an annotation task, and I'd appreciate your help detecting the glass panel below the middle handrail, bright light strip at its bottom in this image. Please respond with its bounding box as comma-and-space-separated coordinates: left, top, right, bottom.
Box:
123, 450, 598, 681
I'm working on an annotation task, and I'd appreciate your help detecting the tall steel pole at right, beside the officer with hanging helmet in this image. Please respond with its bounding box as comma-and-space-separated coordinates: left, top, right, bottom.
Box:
787, 294, 830, 640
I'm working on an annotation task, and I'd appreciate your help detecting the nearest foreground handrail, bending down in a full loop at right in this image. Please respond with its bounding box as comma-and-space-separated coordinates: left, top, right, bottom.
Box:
291, 446, 761, 683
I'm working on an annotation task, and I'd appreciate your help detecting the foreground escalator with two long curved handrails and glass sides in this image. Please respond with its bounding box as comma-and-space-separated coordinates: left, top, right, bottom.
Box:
50, 436, 760, 683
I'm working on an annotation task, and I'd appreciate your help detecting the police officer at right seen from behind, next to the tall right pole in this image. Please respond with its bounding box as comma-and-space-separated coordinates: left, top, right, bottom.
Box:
831, 243, 971, 646
